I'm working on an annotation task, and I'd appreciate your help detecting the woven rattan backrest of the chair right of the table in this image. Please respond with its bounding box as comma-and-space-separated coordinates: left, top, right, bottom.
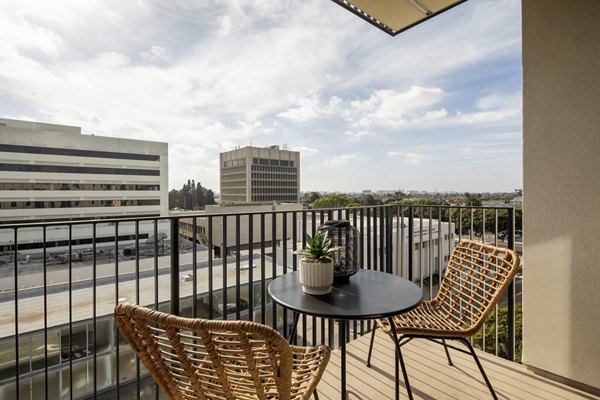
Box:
432, 240, 520, 337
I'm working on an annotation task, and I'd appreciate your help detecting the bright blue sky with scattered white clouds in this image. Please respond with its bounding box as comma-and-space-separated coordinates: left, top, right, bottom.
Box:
0, 0, 522, 192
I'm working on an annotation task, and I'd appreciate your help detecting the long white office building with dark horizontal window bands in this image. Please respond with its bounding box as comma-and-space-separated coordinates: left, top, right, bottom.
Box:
0, 119, 168, 224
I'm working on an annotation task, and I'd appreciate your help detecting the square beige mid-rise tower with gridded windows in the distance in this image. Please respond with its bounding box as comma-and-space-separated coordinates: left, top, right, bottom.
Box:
220, 146, 300, 204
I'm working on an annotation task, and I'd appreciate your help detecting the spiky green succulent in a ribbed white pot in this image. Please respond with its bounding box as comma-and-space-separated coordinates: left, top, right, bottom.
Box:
294, 232, 337, 294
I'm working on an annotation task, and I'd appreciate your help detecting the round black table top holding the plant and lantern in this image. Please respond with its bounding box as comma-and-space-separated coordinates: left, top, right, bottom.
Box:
268, 269, 423, 320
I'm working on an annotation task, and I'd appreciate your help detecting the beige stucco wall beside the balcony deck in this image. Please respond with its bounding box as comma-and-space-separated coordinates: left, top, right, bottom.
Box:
522, 0, 600, 388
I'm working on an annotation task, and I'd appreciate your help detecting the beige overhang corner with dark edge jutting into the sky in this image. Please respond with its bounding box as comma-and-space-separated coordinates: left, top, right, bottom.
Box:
332, 0, 467, 36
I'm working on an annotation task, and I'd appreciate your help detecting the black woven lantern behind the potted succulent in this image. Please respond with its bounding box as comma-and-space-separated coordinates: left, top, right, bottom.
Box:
317, 221, 360, 283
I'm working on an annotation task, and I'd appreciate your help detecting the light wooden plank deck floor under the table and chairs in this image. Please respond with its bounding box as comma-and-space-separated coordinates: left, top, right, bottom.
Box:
318, 333, 599, 400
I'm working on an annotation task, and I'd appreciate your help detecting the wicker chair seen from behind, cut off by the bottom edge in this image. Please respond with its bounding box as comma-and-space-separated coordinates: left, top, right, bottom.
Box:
115, 303, 330, 400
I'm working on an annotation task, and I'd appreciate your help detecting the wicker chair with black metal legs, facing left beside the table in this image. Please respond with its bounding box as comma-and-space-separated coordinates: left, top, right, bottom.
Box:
367, 241, 520, 399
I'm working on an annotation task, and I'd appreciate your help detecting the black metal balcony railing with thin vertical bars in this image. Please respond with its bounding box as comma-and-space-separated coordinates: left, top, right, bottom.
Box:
0, 205, 522, 399
